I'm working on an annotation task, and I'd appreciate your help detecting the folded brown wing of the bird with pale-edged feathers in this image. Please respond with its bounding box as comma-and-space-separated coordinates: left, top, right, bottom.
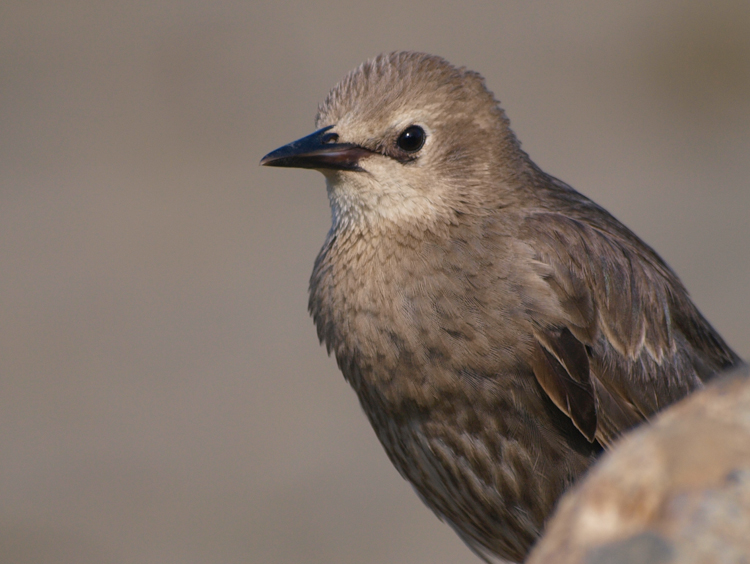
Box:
522, 208, 740, 445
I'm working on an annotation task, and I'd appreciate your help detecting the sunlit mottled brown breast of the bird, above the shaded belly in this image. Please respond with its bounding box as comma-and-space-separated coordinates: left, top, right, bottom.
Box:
310, 225, 531, 410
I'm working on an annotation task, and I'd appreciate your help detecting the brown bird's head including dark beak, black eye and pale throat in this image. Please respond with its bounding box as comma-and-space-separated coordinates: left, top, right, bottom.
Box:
261, 52, 525, 234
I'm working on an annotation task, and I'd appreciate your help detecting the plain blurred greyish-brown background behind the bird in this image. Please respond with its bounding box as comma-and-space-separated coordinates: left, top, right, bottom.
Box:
0, 0, 750, 564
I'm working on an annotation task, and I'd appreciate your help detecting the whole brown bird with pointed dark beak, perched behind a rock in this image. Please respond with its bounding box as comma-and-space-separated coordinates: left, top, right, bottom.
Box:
261, 51, 742, 562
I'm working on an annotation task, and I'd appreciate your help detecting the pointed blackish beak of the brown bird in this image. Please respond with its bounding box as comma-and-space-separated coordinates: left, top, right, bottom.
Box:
260, 125, 373, 171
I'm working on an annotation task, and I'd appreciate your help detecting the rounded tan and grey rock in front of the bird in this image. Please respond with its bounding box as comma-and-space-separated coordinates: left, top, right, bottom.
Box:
527, 367, 750, 564
